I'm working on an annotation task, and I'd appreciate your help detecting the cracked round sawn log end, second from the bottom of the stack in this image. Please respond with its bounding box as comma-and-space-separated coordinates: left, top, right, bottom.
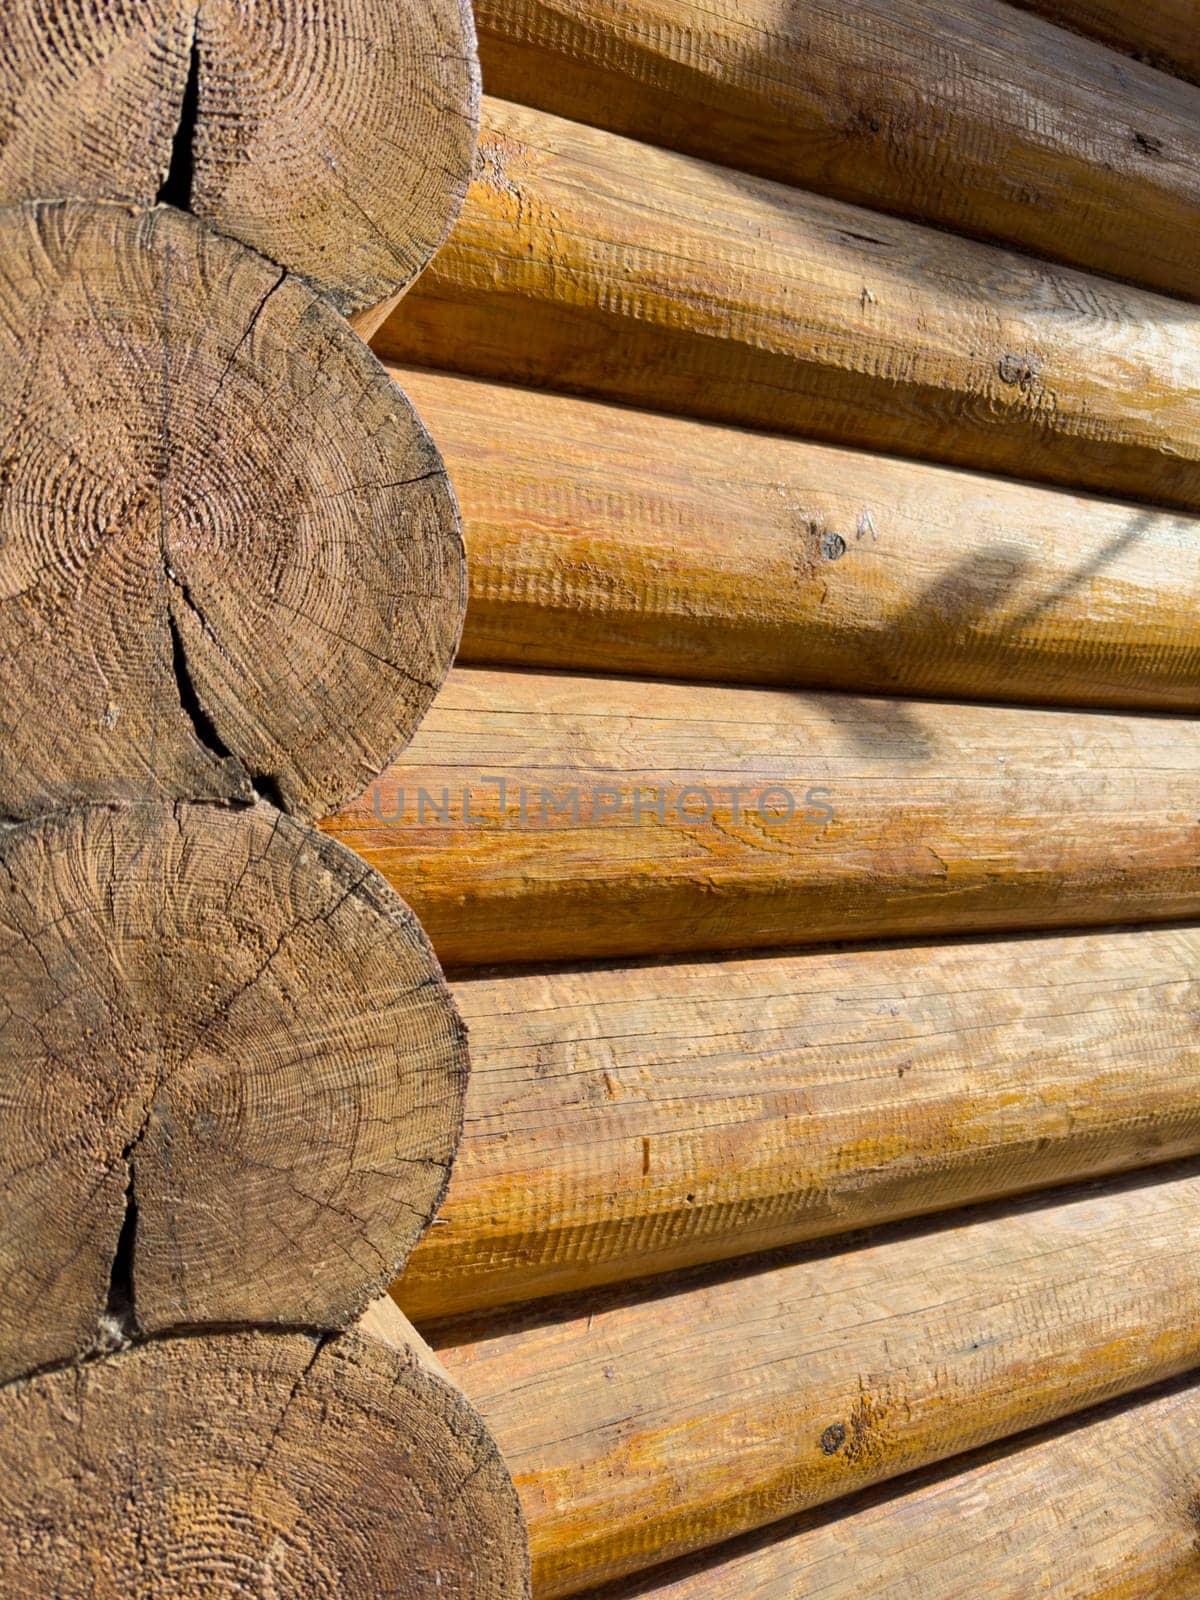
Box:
0, 805, 467, 1388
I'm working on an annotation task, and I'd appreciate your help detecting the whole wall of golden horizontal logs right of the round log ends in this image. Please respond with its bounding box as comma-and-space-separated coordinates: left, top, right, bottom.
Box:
364, 0, 1200, 1600
